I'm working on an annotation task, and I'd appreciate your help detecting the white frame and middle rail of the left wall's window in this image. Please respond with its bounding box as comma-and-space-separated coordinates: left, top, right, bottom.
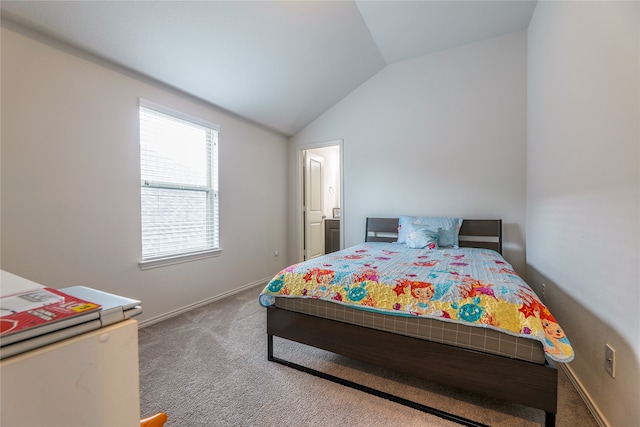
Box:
138, 98, 222, 270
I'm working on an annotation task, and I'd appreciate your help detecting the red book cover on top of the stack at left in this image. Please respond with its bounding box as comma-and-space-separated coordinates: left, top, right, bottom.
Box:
0, 288, 101, 337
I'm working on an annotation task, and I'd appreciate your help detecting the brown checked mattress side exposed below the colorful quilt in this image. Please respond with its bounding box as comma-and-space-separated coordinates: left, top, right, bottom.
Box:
275, 297, 545, 364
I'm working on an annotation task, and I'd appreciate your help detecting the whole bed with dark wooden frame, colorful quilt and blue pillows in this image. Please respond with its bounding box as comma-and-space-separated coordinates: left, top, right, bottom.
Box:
260, 217, 573, 426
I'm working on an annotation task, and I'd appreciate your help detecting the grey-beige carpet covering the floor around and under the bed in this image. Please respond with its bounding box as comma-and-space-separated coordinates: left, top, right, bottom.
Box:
140, 288, 597, 427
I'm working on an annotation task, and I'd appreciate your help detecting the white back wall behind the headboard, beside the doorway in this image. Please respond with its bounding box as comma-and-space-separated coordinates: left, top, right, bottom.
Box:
290, 32, 527, 274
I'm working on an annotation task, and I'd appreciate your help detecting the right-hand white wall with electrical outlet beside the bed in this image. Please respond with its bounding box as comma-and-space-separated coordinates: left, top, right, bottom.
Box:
527, 2, 640, 426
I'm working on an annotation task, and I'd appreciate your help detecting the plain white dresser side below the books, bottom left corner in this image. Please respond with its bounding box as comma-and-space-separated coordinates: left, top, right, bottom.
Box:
0, 274, 140, 427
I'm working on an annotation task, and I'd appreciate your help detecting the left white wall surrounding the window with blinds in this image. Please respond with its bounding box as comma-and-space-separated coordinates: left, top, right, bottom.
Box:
1, 22, 287, 320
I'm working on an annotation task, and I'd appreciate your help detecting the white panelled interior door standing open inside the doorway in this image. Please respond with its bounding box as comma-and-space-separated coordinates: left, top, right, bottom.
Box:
304, 152, 324, 260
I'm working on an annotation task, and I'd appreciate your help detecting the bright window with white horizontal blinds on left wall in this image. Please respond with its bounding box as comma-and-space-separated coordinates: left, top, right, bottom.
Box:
140, 99, 220, 269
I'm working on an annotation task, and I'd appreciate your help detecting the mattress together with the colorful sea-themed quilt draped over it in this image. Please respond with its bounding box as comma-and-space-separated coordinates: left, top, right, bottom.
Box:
259, 242, 574, 363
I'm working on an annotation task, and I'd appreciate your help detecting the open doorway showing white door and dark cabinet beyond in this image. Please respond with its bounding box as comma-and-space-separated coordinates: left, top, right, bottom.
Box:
297, 141, 344, 261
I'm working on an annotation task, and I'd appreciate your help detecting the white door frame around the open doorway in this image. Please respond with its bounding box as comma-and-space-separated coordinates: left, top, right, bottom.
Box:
294, 139, 345, 263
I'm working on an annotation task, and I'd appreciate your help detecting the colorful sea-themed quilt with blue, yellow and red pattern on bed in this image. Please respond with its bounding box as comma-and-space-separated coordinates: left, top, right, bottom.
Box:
260, 242, 574, 362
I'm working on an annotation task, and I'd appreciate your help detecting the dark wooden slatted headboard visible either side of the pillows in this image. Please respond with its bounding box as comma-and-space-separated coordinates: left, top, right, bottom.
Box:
365, 218, 502, 253
